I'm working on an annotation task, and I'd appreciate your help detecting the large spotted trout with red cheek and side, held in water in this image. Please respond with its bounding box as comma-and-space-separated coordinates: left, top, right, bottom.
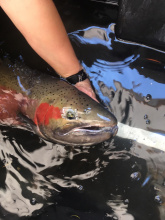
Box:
0, 60, 117, 145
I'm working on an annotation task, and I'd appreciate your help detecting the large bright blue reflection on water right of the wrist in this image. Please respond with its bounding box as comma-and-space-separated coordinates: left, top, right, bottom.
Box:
83, 60, 165, 99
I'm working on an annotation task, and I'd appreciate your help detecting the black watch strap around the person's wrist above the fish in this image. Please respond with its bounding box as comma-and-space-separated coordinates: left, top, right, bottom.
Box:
66, 69, 88, 85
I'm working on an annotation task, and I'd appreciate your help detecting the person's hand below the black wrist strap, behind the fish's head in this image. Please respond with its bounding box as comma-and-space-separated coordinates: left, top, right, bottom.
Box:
75, 79, 99, 102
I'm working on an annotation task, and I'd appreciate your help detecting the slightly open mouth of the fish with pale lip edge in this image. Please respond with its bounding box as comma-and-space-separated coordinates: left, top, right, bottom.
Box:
69, 125, 118, 136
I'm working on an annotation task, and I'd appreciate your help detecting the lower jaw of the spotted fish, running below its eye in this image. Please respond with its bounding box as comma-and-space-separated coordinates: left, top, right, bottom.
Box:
38, 122, 118, 146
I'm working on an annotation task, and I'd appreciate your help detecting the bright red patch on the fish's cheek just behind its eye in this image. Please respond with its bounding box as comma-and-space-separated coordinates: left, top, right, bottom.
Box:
34, 103, 61, 125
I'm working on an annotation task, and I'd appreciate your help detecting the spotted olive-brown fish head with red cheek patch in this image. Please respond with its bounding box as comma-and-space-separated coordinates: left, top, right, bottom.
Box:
35, 83, 117, 145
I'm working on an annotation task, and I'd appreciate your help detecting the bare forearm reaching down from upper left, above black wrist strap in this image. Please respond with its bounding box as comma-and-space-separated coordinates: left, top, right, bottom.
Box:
0, 0, 82, 77
